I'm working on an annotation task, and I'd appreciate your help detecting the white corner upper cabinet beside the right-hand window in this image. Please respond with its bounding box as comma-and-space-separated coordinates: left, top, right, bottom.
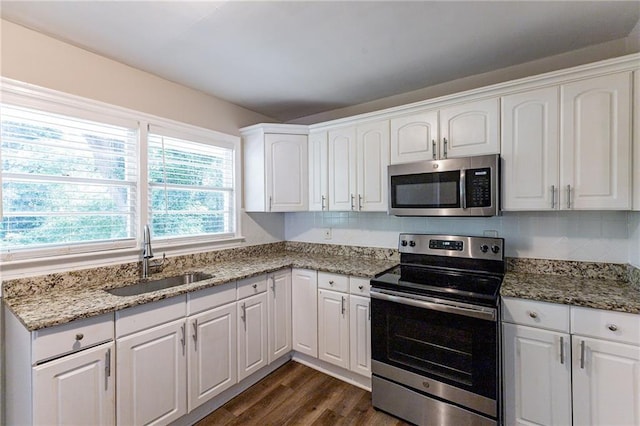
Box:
241, 124, 309, 212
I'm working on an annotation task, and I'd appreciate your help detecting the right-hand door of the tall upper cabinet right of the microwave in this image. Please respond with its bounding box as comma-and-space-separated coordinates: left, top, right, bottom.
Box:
560, 73, 631, 210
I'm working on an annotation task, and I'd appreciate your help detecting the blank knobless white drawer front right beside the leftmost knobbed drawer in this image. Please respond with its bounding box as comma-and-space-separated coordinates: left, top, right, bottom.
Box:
116, 295, 187, 338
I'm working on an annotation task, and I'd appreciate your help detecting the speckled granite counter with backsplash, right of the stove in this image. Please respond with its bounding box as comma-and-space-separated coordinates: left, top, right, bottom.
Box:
500, 259, 640, 314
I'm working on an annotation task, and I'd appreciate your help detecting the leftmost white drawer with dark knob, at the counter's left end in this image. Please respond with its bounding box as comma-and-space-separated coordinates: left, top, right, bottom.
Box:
32, 313, 113, 364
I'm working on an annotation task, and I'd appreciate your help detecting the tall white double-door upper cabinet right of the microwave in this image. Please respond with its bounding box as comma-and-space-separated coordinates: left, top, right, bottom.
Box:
502, 73, 631, 210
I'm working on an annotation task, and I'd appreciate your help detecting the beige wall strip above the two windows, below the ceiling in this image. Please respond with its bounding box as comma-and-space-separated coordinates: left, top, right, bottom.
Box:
0, 20, 275, 135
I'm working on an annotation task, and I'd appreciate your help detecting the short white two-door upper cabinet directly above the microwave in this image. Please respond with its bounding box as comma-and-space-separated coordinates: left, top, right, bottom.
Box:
391, 98, 500, 164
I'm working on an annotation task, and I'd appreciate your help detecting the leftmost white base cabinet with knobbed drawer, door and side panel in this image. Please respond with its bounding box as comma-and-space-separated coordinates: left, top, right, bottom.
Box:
3, 309, 116, 425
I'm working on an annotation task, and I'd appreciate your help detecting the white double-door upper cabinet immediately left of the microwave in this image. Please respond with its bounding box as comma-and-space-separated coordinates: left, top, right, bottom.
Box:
328, 120, 389, 211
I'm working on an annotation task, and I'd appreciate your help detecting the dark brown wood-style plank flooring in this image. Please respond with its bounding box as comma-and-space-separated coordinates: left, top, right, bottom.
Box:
196, 361, 406, 426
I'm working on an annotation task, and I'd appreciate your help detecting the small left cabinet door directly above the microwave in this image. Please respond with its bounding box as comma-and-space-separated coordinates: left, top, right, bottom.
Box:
391, 111, 439, 164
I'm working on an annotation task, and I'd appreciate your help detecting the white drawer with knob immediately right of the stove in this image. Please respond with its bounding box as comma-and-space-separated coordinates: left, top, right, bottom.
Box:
502, 297, 570, 333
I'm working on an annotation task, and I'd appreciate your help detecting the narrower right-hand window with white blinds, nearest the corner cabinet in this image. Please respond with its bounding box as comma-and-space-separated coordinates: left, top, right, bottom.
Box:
147, 126, 235, 238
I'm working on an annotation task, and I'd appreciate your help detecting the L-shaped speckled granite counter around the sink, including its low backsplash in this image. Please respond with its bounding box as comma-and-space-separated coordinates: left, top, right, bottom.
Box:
4, 245, 397, 331
